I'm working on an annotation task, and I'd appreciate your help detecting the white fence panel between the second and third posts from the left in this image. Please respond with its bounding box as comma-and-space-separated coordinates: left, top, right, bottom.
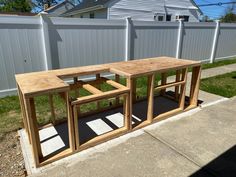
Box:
131, 21, 178, 59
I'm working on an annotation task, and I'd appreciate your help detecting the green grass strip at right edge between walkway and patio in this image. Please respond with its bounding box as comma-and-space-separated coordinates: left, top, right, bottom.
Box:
200, 71, 236, 98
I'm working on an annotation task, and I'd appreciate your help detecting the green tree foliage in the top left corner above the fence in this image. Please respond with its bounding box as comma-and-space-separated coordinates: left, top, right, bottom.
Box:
0, 0, 32, 12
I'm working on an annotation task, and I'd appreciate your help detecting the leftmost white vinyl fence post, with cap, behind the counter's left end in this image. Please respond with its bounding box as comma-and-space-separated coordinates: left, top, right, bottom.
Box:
40, 13, 52, 71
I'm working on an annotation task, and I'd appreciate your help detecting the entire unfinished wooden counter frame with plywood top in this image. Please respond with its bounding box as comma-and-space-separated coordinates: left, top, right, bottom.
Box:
16, 57, 201, 167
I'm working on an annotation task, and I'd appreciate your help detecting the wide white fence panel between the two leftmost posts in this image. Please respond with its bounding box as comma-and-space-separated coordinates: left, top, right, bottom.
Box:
49, 18, 125, 68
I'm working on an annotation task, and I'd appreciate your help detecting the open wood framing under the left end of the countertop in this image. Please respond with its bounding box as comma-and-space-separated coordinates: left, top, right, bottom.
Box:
18, 87, 75, 167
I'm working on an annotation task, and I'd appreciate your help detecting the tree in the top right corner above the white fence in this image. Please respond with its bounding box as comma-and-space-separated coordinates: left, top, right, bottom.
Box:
220, 0, 236, 23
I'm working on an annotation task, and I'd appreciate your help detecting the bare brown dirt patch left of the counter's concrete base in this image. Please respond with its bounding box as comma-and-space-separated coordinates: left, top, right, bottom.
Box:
0, 131, 26, 177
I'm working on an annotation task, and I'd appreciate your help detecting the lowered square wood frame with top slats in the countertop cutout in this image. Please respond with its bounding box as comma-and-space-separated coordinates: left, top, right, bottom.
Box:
71, 78, 130, 151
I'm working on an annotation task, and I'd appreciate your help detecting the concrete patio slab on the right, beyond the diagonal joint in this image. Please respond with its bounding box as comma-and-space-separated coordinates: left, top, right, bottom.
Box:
144, 98, 236, 176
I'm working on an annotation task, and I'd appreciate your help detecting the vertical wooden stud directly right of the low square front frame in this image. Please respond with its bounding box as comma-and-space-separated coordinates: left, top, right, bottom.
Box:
126, 78, 133, 130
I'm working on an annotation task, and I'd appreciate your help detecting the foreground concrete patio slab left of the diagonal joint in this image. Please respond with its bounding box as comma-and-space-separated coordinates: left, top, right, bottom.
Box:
30, 134, 210, 177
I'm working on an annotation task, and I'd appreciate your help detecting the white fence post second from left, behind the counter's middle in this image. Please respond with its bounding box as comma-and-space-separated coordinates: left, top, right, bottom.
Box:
125, 17, 131, 61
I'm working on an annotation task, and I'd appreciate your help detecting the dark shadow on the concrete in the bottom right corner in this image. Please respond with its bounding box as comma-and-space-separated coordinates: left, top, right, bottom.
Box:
190, 146, 236, 177
